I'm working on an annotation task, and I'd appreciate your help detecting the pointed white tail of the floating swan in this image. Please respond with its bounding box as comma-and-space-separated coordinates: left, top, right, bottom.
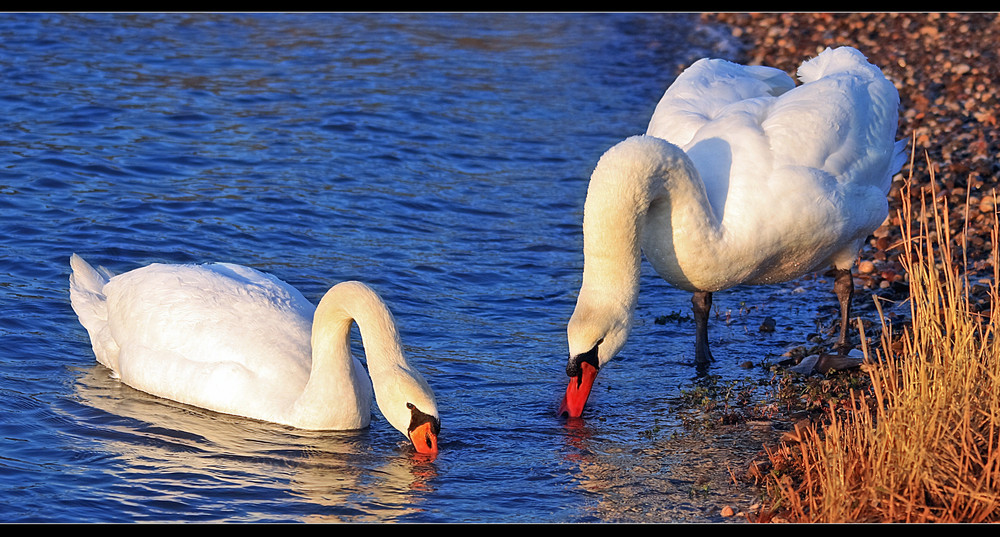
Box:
69, 254, 118, 370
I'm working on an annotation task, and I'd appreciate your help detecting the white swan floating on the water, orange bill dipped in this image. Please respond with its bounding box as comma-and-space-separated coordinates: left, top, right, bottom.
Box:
70, 254, 440, 453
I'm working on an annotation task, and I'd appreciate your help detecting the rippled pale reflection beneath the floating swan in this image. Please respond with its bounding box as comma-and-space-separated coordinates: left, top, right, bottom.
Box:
74, 364, 437, 522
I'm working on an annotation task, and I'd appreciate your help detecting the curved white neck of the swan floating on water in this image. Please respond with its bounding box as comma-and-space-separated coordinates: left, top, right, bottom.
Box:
296, 282, 405, 424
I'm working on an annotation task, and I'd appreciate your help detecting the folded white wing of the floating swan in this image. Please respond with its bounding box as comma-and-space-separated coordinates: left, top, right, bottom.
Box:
105, 265, 312, 379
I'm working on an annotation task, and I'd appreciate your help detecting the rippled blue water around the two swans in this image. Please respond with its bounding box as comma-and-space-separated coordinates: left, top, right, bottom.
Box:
0, 14, 844, 522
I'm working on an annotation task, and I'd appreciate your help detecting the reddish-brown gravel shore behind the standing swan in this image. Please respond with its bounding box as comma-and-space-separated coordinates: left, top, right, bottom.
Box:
702, 13, 1000, 314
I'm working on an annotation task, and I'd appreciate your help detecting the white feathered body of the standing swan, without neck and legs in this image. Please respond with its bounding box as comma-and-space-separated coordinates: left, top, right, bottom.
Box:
644, 47, 906, 291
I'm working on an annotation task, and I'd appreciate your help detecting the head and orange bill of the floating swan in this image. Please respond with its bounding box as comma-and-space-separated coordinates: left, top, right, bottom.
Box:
373, 366, 441, 455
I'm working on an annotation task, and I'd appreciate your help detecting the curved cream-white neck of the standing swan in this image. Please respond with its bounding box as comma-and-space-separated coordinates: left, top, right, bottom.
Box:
581, 136, 720, 304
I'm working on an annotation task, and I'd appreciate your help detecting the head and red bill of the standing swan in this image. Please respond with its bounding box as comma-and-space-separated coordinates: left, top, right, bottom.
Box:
557, 300, 632, 418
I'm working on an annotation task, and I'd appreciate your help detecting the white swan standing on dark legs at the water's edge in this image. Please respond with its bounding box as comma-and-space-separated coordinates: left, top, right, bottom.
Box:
559, 47, 906, 417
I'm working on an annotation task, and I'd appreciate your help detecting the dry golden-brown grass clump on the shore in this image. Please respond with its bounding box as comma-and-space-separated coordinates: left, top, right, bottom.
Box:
765, 153, 1000, 522
